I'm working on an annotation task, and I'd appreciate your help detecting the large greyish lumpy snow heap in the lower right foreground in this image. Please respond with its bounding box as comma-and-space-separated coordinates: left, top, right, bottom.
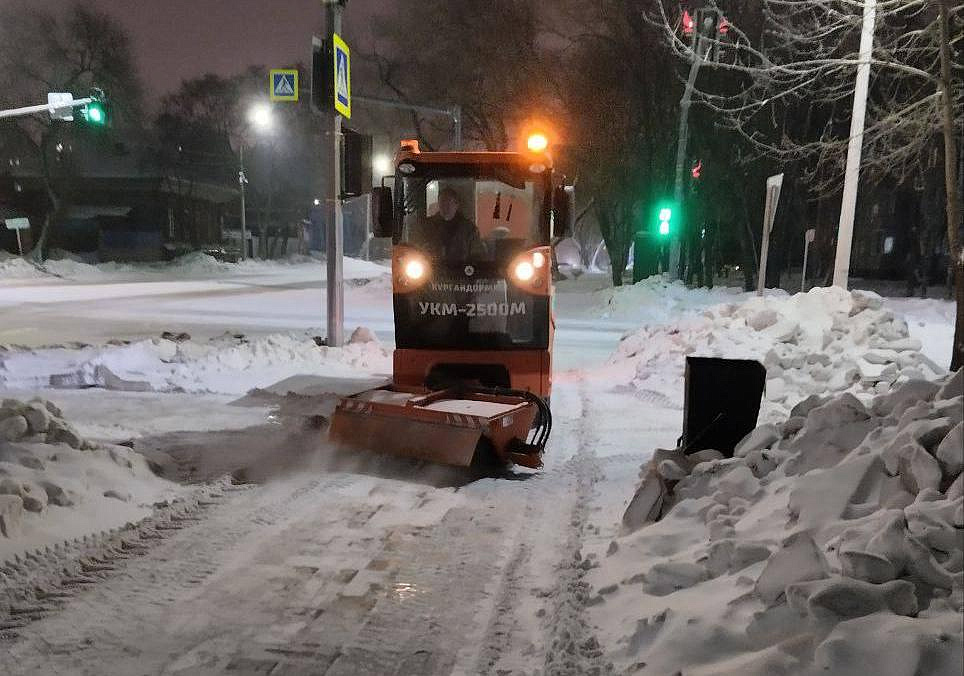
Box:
584, 371, 964, 676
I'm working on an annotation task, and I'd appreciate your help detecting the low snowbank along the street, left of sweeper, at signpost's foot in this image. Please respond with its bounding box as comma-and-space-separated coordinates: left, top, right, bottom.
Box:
0, 329, 392, 394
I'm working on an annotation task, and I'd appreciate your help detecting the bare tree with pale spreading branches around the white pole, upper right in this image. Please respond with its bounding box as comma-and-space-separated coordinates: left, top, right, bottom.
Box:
656, 0, 964, 368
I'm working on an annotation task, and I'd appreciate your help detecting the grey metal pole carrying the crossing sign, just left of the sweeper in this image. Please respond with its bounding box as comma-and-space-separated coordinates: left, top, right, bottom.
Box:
322, 0, 347, 347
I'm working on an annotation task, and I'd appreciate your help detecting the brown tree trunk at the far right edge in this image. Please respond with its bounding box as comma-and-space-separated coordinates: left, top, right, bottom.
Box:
939, 0, 964, 371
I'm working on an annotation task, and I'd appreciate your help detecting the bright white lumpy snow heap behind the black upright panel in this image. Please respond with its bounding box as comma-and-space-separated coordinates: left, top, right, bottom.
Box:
612, 287, 946, 420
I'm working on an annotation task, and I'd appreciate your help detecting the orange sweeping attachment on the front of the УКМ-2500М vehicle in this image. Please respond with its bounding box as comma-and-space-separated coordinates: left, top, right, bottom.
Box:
329, 387, 542, 467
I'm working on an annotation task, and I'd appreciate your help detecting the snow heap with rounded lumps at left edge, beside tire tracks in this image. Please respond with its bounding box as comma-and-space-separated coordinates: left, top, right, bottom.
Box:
0, 399, 178, 561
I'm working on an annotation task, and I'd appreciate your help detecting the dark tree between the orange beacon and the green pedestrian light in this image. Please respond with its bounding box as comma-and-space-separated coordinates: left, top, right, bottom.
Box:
559, 0, 679, 286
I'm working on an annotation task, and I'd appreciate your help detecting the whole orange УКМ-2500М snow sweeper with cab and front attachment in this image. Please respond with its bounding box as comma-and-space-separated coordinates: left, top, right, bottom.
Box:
330, 135, 574, 468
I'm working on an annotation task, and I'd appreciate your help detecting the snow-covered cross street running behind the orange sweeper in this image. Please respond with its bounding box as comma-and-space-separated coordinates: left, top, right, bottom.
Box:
0, 263, 638, 369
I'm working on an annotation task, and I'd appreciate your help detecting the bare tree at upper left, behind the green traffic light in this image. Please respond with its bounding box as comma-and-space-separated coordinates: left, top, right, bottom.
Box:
0, 2, 142, 259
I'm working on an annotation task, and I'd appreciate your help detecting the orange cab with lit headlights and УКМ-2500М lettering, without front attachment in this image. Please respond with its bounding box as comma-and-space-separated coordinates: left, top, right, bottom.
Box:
374, 141, 573, 399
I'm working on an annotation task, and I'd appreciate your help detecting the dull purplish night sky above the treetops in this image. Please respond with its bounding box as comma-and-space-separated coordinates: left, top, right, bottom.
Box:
23, 0, 387, 101
